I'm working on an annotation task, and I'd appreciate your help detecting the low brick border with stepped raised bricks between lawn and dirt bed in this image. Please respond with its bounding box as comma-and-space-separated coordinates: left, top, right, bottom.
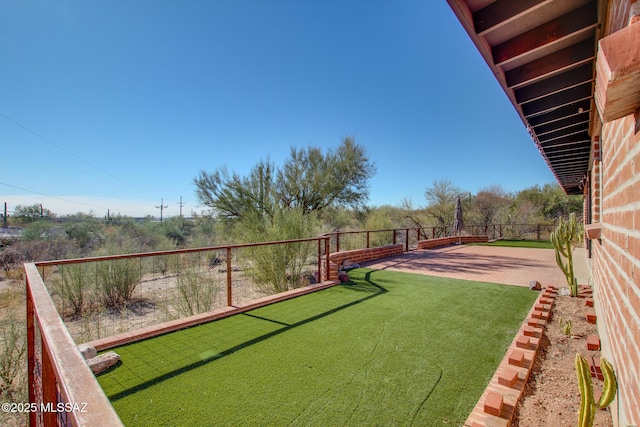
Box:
464, 286, 558, 427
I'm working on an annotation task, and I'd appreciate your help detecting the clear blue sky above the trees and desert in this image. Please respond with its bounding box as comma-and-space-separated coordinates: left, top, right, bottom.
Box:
0, 0, 554, 216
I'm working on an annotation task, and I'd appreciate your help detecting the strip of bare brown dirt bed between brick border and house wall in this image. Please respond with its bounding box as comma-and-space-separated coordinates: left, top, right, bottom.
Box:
512, 296, 613, 427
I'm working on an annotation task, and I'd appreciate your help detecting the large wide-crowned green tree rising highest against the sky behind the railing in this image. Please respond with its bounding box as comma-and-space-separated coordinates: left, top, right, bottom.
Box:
194, 137, 375, 224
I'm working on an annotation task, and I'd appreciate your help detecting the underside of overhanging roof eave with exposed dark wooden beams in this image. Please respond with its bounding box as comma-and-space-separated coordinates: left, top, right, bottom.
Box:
447, 0, 603, 194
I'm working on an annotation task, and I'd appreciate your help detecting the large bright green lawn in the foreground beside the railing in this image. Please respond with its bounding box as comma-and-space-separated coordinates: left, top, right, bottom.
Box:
98, 269, 537, 426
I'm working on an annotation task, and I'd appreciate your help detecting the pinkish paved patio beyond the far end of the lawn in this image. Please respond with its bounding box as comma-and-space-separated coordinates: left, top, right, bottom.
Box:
362, 245, 590, 287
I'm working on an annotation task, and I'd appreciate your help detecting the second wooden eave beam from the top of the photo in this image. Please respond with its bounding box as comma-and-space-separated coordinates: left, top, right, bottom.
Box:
491, 2, 598, 65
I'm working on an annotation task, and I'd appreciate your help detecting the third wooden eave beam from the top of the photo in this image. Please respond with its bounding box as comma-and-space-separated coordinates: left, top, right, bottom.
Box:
505, 38, 596, 89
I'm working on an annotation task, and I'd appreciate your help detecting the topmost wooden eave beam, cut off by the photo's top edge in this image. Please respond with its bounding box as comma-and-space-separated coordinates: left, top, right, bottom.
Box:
473, 0, 553, 36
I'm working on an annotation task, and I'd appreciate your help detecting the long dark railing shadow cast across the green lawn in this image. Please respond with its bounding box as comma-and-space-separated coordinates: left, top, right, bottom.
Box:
109, 271, 388, 401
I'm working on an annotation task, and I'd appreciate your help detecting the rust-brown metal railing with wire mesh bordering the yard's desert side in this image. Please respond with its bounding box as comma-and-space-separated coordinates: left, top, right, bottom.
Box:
24, 224, 555, 426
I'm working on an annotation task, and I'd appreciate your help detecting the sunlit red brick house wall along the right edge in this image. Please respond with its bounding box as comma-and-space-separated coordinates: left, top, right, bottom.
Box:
592, 115, 640, 426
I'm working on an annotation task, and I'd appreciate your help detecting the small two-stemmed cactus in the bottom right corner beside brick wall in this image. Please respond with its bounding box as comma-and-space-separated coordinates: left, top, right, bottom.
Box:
576, 353, 618, 427
